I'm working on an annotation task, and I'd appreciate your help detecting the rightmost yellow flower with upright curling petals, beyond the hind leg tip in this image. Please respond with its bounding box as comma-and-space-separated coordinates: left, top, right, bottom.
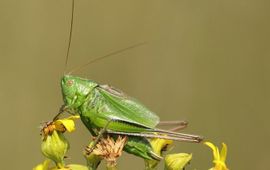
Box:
204, 142, 228, 170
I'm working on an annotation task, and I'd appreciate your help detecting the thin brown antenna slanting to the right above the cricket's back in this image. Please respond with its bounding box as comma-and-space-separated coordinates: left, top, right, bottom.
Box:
68, 42, 146, 74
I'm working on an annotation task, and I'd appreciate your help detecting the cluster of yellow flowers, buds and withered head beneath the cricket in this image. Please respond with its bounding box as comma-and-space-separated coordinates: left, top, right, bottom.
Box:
33, 116, 229, 170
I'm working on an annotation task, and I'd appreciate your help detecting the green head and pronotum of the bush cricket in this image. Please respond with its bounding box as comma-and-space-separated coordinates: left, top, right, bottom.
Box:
61, 75, 97, 109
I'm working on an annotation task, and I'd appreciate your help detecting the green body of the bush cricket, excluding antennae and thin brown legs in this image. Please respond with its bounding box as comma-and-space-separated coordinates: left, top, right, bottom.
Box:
61, 75, 200, 159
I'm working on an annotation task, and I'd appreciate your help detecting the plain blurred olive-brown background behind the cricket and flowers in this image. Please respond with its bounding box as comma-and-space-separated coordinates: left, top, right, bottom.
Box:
0, 0, 270, 170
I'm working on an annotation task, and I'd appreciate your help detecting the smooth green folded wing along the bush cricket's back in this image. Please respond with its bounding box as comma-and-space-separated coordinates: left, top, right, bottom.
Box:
97, 85, 159, 129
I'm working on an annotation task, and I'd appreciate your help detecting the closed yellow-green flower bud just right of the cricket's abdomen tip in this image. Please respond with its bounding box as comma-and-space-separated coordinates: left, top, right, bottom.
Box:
165, 153, 192, 170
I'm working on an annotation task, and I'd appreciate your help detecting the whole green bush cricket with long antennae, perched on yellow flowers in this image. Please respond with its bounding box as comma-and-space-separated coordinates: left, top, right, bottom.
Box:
52, 0, 202, 159
